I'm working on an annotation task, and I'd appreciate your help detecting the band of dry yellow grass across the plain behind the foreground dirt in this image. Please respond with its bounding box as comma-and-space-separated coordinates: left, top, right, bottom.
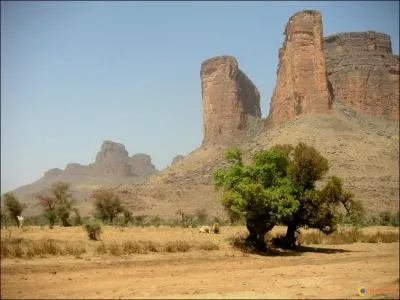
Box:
1, 226, 399, 258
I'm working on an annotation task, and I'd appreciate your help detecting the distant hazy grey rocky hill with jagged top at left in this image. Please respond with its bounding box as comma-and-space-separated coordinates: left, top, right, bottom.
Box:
12, 141, 158, 215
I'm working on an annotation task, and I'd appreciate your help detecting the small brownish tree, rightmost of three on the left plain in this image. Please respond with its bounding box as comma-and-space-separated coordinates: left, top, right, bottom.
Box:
91, 190, 124, 223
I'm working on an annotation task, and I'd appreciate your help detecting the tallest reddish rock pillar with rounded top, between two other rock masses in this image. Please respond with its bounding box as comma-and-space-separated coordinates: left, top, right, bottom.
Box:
266, 10, 332, 125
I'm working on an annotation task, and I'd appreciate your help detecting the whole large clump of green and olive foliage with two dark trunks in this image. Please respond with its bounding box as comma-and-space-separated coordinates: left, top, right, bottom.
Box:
214, 143, 362, 248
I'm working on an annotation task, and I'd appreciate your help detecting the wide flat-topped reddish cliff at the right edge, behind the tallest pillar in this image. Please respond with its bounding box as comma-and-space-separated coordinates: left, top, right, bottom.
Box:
324, 31, 399, 120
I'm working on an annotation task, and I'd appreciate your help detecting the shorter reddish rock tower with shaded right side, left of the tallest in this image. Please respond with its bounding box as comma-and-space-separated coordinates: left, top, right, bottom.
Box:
200, 56, 261, 146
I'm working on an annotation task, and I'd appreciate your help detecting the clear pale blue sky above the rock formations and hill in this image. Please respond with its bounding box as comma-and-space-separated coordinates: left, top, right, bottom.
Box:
1, 1, 399, 193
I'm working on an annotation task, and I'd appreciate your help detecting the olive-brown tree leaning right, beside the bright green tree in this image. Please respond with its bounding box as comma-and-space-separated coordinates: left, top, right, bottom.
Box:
277, 143, 363, 248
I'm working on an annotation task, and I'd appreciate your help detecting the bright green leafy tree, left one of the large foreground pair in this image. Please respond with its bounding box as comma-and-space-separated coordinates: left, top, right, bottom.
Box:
214, 148, 298, 250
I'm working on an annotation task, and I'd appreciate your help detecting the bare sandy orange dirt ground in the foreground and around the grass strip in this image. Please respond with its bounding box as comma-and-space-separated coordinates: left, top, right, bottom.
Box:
1, 227, 399, 299
